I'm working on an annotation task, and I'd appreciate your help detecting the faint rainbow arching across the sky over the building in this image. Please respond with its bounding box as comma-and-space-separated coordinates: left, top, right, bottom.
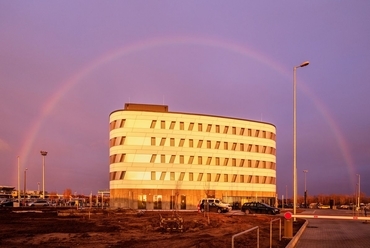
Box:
20, 36, 355, 192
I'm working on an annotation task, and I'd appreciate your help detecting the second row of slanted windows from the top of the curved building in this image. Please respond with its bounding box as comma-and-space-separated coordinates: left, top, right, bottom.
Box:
110, 136, 276, 155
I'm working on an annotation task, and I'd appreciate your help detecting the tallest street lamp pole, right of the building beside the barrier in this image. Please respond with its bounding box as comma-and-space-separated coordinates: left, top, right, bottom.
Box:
293, 61, 310, 221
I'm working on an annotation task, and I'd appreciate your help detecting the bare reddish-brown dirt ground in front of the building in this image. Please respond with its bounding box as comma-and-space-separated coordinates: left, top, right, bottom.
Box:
0, 208, 304, 248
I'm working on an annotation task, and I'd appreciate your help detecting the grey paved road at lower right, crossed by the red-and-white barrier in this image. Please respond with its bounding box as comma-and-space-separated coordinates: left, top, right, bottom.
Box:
295, 209, 370, 248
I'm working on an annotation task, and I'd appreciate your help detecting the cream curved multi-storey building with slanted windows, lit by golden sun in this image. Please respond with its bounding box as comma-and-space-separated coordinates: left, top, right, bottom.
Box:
109, 104, 276, 209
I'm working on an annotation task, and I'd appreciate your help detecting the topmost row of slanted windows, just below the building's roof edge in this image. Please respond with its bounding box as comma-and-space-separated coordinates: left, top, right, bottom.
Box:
110, 119, 276, 140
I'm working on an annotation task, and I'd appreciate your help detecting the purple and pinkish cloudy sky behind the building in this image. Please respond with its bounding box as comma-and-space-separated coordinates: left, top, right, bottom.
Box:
0, 0, 370, 197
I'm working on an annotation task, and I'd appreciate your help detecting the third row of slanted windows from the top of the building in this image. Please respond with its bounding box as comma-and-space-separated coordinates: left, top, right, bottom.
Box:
110, 154, 276, 170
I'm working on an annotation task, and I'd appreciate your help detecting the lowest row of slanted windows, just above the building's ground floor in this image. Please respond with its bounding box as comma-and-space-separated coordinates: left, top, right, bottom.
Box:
110, 171, 276, 184
